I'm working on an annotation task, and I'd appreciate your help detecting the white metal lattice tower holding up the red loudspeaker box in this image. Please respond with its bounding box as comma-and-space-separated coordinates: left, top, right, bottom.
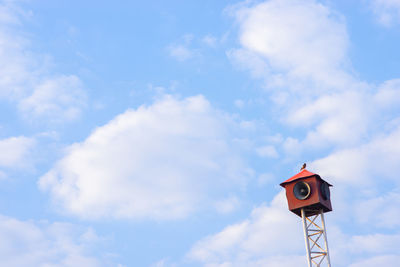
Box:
301, 208, 331, 267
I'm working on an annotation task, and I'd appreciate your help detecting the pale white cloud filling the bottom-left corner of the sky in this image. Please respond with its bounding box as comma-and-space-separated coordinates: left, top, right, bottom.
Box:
0, 215, 105, 267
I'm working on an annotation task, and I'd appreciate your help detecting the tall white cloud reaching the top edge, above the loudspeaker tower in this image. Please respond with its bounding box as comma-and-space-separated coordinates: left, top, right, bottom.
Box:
228, 0, 378, 153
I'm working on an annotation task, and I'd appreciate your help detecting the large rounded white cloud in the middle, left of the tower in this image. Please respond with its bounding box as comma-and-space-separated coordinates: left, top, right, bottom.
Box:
39, 96, 250, 219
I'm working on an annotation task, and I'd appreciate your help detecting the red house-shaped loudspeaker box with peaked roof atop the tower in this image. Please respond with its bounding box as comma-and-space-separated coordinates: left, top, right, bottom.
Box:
280, 169, 332, 217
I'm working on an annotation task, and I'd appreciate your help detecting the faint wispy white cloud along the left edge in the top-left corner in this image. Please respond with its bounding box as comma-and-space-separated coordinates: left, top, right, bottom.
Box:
0, 1, 86, 121
